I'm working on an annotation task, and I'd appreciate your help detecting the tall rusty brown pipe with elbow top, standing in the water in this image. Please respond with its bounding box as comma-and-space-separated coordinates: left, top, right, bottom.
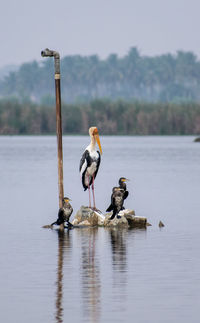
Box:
41, 48, 64, 228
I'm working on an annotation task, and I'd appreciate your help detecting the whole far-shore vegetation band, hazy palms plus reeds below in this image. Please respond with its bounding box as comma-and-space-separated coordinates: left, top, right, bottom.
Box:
0, 48, 200, 135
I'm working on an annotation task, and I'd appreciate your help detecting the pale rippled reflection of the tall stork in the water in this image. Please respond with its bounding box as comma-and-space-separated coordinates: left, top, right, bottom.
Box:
81, 228, 101, 323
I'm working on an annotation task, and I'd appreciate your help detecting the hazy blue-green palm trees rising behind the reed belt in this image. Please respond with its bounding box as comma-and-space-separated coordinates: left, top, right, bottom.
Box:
0, 47, 200, 105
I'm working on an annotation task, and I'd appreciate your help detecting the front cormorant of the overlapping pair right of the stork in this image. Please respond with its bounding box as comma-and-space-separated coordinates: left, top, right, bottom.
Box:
106, 187, 125, 220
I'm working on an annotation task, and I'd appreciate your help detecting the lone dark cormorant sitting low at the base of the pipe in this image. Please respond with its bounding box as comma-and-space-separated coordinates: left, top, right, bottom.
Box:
51, 197, 73, 228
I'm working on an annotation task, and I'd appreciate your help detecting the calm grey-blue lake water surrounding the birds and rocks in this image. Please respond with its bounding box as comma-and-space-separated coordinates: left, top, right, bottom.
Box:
0, 136, 200, 323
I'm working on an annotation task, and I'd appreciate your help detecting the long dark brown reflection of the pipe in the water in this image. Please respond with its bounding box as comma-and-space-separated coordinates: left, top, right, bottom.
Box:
55, 230, 70, 323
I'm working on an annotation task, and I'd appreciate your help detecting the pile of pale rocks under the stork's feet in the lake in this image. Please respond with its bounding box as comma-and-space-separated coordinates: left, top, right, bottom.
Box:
72, 206, 147, 228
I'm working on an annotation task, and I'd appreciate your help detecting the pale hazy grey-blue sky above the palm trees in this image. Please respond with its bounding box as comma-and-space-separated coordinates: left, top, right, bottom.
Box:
0, 0, 200, 67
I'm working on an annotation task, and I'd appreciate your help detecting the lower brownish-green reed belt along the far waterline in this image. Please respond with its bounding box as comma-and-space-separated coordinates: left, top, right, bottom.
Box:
0, 100, 200, 135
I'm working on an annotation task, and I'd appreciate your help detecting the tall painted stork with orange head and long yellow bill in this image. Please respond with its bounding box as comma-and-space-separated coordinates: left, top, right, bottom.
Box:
79, 127, 102, 209
